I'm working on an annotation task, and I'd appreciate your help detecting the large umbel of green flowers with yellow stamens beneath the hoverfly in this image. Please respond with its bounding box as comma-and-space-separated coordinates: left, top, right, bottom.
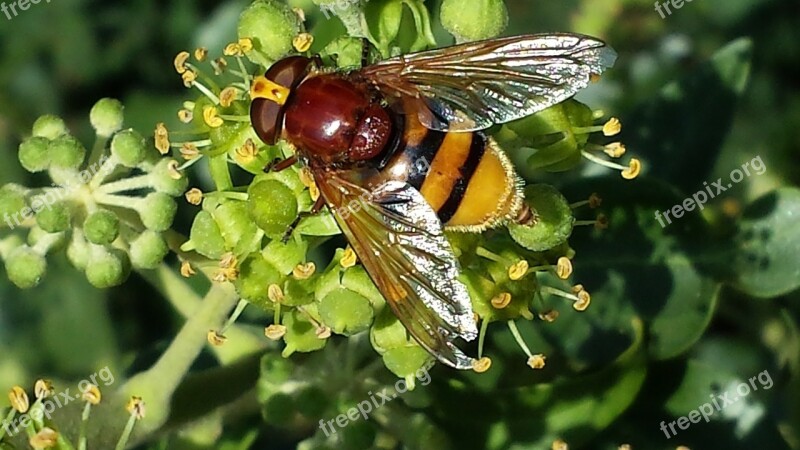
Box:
164, 0, 640, 377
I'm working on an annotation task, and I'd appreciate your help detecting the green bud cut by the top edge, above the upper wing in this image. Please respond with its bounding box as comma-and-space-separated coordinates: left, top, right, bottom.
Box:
441, 0, 508, 42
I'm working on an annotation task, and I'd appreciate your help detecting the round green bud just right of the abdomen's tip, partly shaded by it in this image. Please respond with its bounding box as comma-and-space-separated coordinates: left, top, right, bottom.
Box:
508, 184, 575, 252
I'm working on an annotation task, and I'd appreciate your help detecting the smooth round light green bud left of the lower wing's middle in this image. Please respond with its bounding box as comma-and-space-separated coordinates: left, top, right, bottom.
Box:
318, 288, 375, 336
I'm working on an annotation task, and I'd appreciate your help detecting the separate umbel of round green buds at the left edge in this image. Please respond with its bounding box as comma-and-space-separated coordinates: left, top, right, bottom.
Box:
0, 99, 187, 288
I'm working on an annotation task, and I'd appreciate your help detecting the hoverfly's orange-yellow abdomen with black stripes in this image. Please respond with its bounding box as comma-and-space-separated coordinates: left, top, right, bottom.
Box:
382, 99, 522, 231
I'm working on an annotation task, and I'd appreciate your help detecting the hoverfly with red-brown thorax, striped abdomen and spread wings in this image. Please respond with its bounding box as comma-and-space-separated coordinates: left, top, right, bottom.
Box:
250, 33, 616, 369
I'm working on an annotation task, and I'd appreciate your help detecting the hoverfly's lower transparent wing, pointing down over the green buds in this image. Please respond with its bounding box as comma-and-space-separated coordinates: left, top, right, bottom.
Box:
315, 170, 477, 369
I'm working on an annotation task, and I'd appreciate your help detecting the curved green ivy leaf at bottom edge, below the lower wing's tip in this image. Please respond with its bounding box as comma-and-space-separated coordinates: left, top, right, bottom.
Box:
432, 320, 647, 449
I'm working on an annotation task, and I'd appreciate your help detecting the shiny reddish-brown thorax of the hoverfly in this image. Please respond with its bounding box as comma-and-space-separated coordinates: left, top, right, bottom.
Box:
284, 74, 392, 162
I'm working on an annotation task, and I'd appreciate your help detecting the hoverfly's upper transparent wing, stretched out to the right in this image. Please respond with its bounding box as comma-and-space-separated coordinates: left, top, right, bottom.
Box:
360, 33, 617, 131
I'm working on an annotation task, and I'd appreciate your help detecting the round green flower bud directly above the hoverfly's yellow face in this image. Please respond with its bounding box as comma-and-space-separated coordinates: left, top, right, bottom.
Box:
239, 0, 302, 67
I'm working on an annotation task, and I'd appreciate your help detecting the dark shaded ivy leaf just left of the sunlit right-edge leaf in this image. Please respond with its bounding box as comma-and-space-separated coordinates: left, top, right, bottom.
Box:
565, 177, 719, 359
